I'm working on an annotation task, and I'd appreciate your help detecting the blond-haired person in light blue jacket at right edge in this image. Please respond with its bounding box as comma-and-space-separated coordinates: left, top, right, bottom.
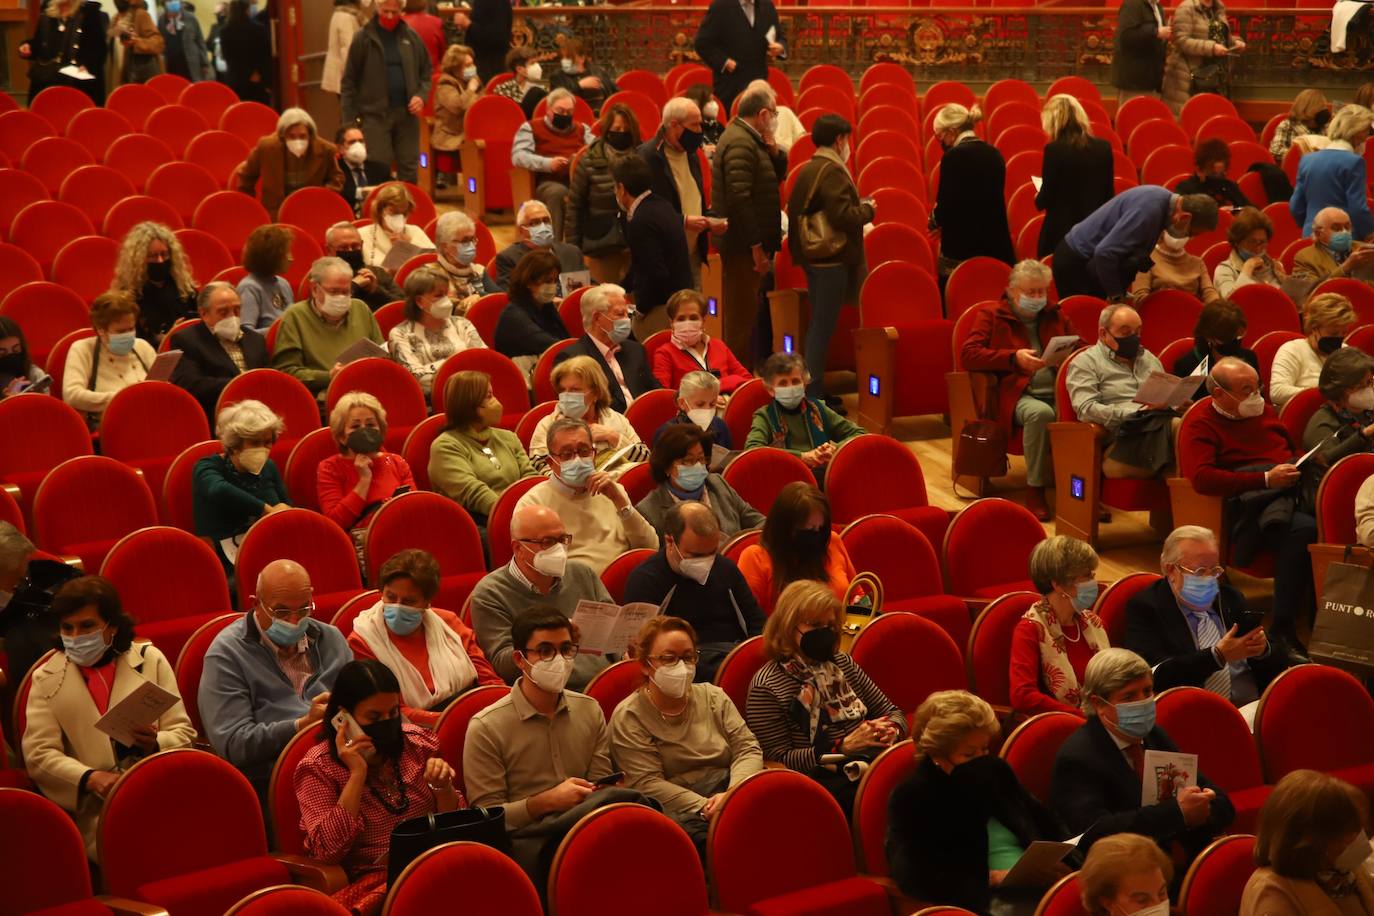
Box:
1289, 104, 1374, 239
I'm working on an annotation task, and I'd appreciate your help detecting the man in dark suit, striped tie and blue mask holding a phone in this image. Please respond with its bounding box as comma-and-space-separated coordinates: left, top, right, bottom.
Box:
1125, 525, 1287, 706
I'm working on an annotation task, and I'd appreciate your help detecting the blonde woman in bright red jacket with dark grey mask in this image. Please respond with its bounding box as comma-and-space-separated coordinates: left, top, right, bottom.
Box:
315, 391, 415, 544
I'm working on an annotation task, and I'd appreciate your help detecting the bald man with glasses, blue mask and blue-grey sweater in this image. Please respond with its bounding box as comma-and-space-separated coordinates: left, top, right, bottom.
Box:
199, 560, 353, 798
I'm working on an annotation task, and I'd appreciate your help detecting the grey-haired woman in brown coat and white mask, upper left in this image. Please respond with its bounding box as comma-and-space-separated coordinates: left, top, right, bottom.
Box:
238, 108, 344, 220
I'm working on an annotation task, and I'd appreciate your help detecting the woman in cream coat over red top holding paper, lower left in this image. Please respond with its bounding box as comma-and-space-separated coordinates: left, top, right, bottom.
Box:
23, 575, 195, 861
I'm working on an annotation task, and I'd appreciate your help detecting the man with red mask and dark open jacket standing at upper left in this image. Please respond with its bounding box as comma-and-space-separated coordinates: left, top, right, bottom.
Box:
339, 0, 433, 181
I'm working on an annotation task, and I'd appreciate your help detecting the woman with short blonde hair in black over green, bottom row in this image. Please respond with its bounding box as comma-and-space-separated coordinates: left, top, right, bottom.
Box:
886, 691, 1069, 913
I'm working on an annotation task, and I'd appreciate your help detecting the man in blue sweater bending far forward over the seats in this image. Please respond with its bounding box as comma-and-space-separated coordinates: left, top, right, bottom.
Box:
1052, 184, 1217, 299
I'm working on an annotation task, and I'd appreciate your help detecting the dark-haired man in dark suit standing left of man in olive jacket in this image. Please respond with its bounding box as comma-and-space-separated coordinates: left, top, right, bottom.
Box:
610, 155, 692, 341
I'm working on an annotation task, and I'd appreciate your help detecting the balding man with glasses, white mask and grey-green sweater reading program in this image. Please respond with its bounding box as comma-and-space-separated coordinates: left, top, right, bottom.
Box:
471, 505, 611, 691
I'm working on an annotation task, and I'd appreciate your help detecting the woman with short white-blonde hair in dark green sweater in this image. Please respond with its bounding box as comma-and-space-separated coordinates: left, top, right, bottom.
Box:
191, 401, 291, 569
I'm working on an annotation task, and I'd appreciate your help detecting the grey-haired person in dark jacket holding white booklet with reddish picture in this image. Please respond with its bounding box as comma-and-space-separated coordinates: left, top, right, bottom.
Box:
1050, 648, 1235, 860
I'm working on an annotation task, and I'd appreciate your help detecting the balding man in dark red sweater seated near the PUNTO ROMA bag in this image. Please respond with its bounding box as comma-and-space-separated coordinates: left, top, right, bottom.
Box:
1179, 357, 1316, 663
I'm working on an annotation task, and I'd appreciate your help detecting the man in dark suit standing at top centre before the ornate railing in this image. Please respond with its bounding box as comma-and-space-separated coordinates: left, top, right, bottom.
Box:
692, 0, 786, 111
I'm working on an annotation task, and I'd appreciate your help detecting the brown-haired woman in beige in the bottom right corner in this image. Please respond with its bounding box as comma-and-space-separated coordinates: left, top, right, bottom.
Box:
1241, 769, 1374, 916
